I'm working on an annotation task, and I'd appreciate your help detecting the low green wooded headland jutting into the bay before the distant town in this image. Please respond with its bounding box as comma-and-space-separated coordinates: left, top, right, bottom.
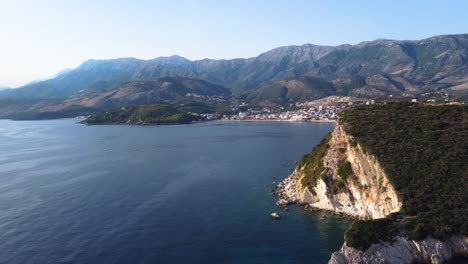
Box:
85, 104, 200, 125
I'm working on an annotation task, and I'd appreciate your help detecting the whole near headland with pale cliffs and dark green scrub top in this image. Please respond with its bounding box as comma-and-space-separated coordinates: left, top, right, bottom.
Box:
277, 105, 468, 264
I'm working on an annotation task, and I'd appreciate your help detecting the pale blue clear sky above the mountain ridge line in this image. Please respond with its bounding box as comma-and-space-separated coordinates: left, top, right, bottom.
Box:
0, 0, 468, 87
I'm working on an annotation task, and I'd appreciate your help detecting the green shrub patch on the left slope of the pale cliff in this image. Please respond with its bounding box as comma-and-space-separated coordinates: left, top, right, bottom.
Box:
297, 133, 331, 189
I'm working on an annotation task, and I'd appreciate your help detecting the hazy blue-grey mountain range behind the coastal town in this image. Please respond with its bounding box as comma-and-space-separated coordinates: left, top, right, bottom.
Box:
0, 34, 468, 118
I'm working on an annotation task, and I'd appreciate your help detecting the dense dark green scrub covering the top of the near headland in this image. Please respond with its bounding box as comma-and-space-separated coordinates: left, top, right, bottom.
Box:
340, 103, 468, 249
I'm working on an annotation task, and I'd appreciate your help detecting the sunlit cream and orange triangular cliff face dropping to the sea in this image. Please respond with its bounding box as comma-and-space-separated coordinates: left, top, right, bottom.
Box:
280, 125, 402, 219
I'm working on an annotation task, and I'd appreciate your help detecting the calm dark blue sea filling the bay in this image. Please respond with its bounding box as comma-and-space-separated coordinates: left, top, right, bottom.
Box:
0, 119, 348, 264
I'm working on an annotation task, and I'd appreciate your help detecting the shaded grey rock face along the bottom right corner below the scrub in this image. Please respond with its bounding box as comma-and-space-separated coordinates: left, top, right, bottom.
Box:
329, 236, 468, 264
